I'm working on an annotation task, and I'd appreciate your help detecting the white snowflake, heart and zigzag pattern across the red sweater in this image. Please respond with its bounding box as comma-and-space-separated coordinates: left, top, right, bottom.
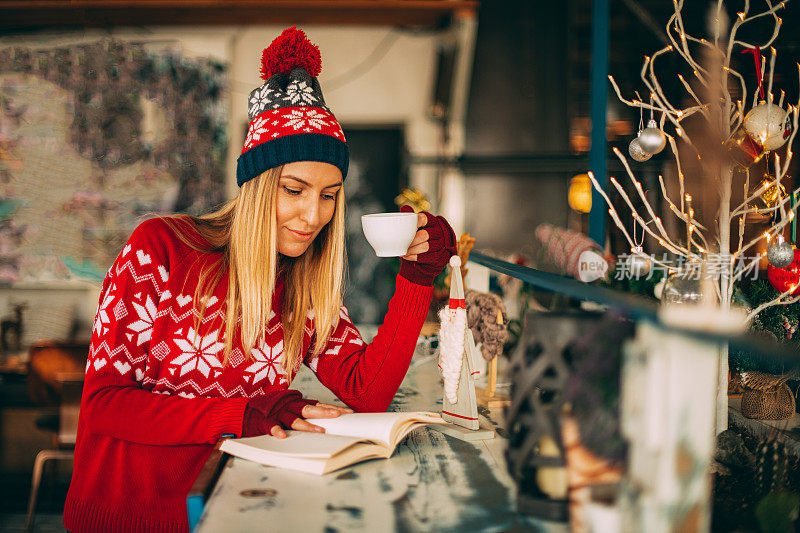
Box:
87, 235, 320, 398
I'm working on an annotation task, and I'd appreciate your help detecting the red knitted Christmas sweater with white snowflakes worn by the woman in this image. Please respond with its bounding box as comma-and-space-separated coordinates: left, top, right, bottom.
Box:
64, 219, 432, 533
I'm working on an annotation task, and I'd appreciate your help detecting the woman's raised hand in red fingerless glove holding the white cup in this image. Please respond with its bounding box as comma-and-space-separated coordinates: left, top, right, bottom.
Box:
400, 205, 456, 286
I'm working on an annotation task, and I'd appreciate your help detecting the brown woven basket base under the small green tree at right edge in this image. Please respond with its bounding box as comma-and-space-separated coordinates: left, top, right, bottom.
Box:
742, 371, 794, 420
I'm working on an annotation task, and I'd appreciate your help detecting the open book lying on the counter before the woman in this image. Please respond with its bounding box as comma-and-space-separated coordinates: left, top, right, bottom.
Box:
220, 411, 444, 475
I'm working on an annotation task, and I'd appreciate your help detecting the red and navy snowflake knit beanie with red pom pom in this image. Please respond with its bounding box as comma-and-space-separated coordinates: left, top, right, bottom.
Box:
236, 26, 349, 187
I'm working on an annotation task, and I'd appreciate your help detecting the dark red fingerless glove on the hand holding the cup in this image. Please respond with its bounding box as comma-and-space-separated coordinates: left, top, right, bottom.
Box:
400, 205, 456, 287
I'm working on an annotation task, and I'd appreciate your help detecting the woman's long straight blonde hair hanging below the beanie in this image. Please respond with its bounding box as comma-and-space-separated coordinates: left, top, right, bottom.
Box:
162, 167, 345, 372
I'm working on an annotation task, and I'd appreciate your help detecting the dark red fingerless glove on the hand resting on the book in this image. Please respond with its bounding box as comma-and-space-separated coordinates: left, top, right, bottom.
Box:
242, 389, 317, 437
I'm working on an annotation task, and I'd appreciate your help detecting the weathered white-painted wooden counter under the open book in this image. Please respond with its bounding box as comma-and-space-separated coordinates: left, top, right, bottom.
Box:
195, 356, 567, 533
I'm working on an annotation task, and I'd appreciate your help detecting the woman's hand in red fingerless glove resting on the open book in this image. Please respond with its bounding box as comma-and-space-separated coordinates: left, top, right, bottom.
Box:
242, 390, 353, 439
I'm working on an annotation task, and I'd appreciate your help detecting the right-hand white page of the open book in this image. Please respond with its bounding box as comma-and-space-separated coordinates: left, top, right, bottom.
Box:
308, 412, 441, 449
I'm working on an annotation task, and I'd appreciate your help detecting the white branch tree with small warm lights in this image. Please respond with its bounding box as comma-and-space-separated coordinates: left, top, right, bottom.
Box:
590, 0, 800, 432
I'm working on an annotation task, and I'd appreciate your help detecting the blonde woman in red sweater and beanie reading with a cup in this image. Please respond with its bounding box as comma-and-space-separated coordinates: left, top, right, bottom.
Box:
64, 28, 455, 533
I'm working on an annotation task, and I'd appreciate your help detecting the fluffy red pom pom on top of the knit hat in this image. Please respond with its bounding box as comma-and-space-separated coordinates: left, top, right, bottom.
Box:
261, 26, 322, 81
